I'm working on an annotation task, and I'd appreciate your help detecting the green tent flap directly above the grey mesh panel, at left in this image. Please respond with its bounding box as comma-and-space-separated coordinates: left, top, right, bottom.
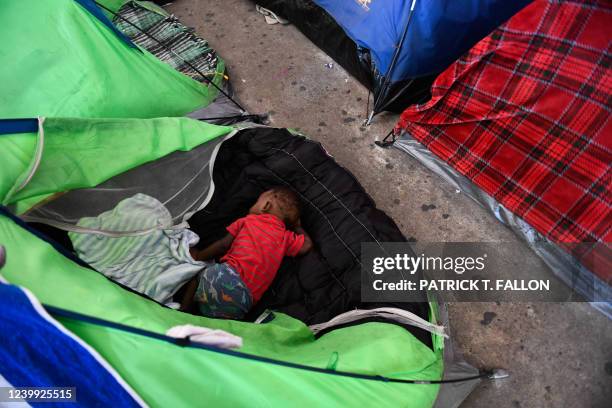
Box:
0, 118, 232, 213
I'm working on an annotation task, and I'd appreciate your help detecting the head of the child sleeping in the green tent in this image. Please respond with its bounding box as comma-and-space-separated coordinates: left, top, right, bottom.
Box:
249, 187, 300, 227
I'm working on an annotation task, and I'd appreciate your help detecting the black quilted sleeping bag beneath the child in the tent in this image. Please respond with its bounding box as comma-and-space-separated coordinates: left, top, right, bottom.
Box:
189, 128, 431, 345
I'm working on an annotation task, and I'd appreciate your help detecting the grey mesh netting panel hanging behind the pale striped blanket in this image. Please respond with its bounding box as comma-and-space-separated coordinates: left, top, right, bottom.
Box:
23, 138, 223, 235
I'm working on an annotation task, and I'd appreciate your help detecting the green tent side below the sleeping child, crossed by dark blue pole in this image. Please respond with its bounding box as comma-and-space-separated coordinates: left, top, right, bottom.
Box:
0, 212, 442, 406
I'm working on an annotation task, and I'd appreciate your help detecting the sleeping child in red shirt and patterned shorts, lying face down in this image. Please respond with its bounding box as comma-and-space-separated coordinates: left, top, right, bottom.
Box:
181, 187, 312, 319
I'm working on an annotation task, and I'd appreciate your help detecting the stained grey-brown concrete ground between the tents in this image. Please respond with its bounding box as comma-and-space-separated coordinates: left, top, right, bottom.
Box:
167, 0, 612, 408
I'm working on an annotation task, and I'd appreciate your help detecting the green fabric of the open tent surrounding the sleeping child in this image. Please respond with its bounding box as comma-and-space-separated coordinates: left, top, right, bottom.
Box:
0, 118, 468, 406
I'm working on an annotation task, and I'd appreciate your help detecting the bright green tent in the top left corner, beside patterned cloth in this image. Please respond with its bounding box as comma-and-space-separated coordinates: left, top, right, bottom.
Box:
0, 0, 225, 118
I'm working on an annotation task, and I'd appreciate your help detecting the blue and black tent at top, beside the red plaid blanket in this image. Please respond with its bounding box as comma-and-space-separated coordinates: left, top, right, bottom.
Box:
251, 0, 530, 113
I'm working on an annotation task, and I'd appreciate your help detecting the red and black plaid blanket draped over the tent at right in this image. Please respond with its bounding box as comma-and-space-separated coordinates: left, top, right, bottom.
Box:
396, 0, 612, 282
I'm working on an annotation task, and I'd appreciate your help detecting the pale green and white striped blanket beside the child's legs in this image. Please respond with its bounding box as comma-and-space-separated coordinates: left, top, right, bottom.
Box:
68, 194, 207, 304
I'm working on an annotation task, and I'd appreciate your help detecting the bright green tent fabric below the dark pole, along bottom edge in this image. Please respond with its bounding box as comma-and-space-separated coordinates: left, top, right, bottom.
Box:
62, 320, 439, 407
